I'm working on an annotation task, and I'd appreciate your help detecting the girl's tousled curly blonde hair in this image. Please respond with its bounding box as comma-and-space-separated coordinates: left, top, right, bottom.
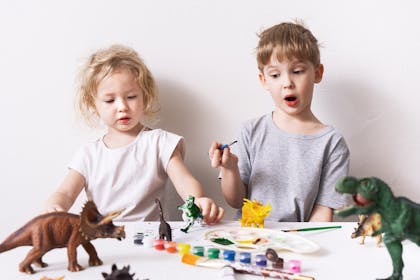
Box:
76, 45, 157, 125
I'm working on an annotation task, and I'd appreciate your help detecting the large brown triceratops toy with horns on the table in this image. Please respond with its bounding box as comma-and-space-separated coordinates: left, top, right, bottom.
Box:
0, 201, 125, 274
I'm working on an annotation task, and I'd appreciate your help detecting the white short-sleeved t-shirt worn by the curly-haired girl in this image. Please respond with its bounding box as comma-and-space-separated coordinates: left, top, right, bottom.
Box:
68, 129, 185, 221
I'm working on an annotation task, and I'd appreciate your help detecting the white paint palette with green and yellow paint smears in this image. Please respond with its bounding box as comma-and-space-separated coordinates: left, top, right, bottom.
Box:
205, 227, 319, 254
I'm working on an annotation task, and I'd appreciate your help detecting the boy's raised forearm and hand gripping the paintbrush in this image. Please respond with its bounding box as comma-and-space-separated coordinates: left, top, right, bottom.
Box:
209, 142, 247, 209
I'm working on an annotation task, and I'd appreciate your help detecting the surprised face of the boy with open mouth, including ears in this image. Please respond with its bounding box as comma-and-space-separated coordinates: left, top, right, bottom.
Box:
259, 53, 324, 117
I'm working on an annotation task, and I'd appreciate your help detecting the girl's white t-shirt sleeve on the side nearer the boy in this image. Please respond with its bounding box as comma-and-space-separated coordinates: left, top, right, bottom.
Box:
158, 130, 185, 171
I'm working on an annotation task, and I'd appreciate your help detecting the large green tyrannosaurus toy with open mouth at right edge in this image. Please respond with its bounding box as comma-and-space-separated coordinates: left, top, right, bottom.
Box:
335, 177, 420, 280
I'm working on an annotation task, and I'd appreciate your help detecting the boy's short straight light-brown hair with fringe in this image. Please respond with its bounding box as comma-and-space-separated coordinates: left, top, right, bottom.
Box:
257, 22, 320, 72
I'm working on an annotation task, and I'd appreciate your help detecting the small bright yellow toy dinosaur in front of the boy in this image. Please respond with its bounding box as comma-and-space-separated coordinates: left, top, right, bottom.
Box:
239, 198, 271, 228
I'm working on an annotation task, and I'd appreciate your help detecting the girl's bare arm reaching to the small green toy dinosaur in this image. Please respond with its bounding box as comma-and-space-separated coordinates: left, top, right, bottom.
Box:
166, 146, 224, 223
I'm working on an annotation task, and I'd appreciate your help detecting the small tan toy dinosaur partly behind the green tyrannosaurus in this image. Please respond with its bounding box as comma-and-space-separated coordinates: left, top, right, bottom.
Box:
351, 213, 382, 247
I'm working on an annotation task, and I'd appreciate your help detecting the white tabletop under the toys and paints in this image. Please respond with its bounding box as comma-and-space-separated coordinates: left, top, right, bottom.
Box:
0, 221, 420, 280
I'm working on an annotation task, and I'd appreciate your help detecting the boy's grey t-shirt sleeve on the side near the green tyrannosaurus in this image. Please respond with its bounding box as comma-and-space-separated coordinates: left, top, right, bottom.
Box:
315, 138, 350, 209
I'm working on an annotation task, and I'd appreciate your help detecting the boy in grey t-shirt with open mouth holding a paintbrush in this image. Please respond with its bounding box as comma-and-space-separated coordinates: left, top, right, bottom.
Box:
209, 23, 349, 222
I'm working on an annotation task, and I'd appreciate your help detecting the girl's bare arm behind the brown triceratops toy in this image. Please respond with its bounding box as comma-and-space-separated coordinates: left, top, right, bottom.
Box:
44, 169, 85, 212
